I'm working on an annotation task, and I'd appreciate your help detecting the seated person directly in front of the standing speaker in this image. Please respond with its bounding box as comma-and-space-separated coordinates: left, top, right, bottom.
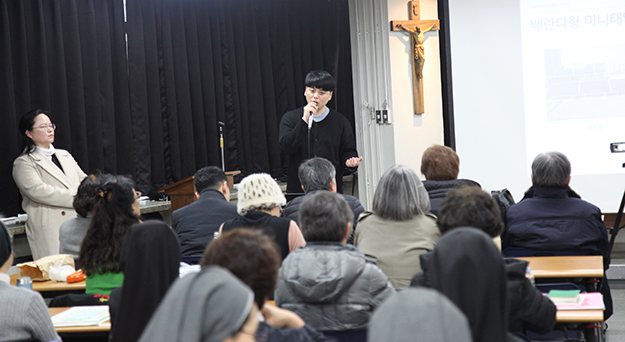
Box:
282, 157, 365, 245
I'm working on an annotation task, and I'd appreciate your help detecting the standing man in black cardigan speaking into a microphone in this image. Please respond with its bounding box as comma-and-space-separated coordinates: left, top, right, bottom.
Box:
280, 71, 362, 193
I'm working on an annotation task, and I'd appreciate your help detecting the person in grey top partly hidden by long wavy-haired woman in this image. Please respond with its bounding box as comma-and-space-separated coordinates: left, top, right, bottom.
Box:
59, 175, 100, 268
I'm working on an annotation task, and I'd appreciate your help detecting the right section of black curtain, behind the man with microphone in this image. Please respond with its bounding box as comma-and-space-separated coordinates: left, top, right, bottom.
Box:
127, 0, 353, 192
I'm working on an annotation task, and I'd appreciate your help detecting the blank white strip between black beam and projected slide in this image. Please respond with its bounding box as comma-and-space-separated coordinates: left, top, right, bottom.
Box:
449, 0, 531, 201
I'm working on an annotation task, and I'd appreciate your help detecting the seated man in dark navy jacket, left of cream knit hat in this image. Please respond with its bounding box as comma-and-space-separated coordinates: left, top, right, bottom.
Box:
171, 166, 239, 259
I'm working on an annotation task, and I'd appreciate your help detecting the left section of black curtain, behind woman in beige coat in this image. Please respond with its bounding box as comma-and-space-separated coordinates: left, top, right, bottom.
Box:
0, 0, 129, 215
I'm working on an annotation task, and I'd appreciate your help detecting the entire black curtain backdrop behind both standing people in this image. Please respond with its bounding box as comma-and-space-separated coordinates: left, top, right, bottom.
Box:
0, 0, 354, 215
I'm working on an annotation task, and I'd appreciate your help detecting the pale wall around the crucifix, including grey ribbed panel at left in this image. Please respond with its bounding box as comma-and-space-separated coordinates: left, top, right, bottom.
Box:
349, 0, 443, 208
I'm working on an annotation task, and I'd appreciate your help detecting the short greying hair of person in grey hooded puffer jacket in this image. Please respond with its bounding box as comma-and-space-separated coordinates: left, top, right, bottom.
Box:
299, 190, 354, 242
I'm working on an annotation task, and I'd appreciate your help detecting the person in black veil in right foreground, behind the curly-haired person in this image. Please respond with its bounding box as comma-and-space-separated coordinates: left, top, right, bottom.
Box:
413, 228, 519, 342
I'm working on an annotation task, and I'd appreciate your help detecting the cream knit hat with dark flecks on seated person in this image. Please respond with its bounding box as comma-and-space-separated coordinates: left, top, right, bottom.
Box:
237, 173, 286, 215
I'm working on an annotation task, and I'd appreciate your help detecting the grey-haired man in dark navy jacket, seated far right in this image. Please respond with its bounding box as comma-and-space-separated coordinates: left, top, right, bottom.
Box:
502, 152, 608, 255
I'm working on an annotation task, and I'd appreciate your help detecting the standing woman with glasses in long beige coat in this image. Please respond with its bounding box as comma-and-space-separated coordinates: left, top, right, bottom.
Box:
13, 109, 87, 260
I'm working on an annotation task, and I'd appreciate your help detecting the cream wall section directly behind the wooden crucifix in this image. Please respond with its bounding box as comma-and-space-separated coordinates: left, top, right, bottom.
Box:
388, 0, 443, 175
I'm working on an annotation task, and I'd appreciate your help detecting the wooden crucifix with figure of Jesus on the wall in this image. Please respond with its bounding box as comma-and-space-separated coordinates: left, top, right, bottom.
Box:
391, 1, 440, 114
